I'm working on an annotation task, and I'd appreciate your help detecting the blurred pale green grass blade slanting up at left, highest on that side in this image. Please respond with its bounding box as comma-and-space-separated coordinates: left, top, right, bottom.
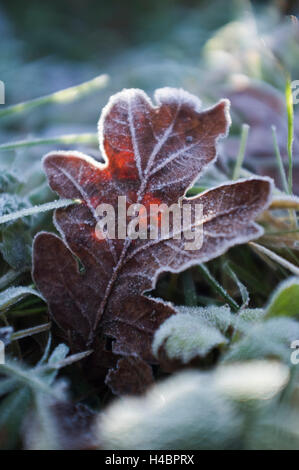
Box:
0, 75, 109, 118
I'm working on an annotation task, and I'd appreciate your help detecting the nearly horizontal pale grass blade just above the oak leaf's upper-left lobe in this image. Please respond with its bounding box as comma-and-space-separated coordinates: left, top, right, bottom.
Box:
0, 133, 98, 152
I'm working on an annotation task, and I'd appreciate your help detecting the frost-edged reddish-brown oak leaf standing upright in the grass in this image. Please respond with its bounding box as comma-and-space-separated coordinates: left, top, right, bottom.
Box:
33, 88, 271, 394
